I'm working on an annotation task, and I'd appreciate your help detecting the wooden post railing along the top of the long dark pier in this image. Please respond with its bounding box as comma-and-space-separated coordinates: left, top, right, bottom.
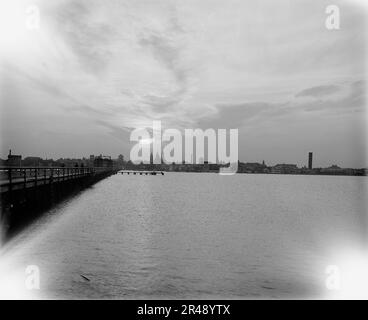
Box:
0, 167, 113, 192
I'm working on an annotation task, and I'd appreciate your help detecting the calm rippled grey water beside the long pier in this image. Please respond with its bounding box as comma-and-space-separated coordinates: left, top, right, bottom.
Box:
3, 173, 367, 299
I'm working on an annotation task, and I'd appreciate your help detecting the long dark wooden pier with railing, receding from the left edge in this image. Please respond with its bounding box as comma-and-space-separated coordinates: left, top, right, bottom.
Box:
0, 167, 118, 240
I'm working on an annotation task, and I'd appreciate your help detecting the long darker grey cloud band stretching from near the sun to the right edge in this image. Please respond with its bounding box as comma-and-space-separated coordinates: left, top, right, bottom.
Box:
198, 80, 366, 128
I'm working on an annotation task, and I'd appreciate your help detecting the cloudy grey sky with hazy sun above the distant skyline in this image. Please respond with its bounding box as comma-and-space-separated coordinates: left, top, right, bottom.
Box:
0, 0, 368, 167
